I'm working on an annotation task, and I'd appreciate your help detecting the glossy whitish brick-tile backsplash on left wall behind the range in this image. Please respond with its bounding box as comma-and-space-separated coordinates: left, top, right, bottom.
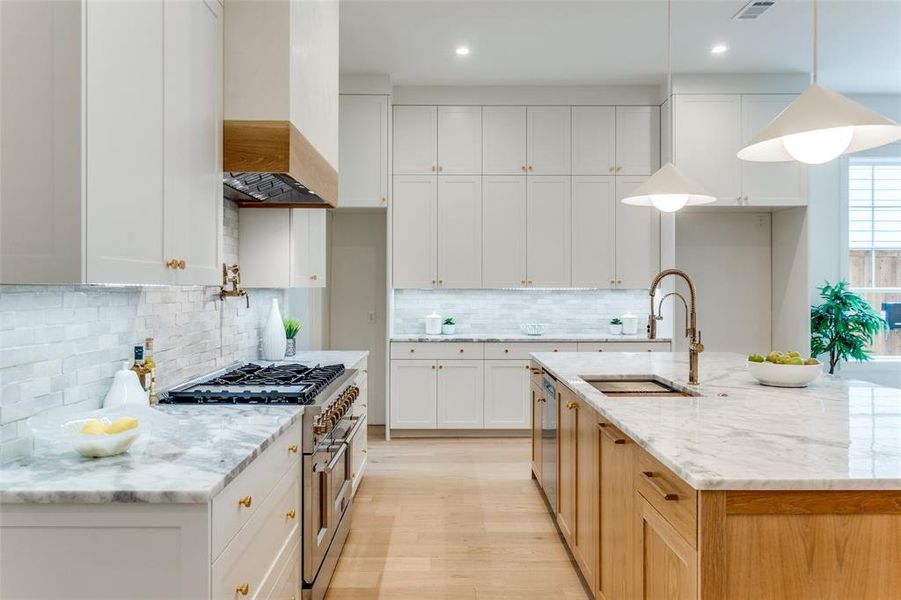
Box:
0, 202, 284, 460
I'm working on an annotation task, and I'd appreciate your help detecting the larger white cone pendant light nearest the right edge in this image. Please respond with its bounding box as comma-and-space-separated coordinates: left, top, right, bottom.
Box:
737, 0, 901, 165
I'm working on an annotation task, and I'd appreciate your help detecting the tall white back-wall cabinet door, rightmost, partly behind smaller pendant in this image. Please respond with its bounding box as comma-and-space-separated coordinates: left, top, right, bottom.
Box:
614, 177, 660, 289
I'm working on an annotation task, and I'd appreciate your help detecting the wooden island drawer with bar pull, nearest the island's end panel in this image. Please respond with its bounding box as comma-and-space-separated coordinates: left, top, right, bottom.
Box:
636, 450, 698, 548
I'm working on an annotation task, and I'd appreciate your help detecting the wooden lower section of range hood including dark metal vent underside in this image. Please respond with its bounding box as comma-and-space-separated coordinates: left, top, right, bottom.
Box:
222, 120, 338, 208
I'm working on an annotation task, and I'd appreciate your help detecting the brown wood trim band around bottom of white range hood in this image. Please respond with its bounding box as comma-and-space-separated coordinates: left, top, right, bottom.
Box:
222, 120, 338, 208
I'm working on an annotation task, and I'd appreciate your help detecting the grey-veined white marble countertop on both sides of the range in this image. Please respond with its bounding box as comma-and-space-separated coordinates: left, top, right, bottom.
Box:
0, 351, 369, 504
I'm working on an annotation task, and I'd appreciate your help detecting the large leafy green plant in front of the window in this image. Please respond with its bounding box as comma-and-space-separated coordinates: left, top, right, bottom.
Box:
810, 281, 888, 374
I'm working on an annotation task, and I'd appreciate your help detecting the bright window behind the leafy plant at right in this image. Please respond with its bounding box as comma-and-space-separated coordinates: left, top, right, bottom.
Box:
848, 157, 901, 356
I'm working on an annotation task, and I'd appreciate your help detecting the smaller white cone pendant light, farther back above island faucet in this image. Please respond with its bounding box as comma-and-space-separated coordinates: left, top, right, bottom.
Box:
621, 0, 716, 213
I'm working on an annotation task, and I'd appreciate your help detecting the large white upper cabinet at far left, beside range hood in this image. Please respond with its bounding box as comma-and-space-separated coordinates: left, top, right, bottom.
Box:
0, 0, 222, 285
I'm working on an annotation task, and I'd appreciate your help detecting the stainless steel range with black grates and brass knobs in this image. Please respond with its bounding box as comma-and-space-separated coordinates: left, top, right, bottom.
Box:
160, 363, 365, 600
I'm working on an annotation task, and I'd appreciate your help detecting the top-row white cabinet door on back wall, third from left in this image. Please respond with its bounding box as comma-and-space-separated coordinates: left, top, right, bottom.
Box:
482, 106, 528, 175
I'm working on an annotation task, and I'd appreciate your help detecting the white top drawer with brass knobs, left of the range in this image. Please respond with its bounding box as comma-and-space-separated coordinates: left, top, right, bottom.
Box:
211, 421, 301, 560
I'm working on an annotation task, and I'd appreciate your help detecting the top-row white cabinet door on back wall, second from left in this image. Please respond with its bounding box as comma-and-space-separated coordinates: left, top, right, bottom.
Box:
438, 106, 482, 175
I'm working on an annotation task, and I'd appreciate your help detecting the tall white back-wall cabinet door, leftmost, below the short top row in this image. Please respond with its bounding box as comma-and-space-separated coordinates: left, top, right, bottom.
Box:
391, 175, 438, 288
